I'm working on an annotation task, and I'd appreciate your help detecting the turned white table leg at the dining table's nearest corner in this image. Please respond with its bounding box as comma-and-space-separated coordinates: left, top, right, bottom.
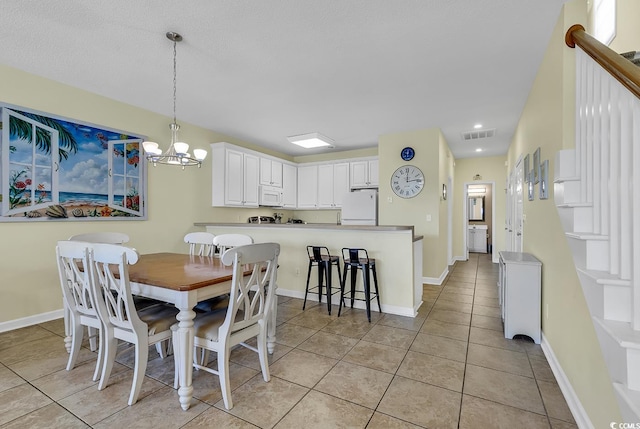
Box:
176, 308, 196, 411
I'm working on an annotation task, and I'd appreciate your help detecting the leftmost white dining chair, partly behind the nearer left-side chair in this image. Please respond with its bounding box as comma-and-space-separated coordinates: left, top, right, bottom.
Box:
56, 241, 104, 381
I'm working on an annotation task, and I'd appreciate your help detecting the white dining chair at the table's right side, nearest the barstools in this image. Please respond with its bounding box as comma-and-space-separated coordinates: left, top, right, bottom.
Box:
171, 243, 280, 410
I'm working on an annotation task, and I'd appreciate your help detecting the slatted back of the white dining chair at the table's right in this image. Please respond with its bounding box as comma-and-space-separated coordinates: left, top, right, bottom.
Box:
220, 243, 280, 336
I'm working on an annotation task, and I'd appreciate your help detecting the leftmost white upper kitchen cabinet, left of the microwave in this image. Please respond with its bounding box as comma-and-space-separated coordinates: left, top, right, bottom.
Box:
211, 143, 260, 207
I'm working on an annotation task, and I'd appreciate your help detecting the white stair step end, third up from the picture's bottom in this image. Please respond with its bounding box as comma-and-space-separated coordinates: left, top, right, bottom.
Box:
577, 268, 632, 322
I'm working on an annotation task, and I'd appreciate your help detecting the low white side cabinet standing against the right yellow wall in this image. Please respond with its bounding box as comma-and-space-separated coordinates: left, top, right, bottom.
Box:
498, 252, 542, 344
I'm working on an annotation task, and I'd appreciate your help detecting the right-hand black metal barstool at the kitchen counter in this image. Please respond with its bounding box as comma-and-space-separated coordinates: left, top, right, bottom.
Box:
338, 247, 382, 322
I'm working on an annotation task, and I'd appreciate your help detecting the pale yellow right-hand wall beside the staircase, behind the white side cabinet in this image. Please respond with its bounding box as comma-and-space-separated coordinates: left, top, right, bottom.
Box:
508, 0, 621, 427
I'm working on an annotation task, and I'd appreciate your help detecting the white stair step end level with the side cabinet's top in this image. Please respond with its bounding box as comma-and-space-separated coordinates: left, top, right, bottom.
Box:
565, 232, 609, 271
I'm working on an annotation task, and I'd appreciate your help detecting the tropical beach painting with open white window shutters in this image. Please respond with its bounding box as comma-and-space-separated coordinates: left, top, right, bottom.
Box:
0, 103, 146, 222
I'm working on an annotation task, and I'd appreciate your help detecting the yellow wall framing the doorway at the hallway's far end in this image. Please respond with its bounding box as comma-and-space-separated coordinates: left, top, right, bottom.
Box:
453, 156, 507, 260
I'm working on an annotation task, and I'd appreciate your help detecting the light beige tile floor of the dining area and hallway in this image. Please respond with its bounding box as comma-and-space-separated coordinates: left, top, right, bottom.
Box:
0, 254, 576, 429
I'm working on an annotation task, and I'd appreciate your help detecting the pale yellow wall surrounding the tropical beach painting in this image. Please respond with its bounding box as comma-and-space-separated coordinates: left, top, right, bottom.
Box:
0, 65, 287, 323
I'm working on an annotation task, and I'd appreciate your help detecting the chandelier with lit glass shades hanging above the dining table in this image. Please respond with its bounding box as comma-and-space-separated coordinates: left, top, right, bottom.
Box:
142, 31, 207, 170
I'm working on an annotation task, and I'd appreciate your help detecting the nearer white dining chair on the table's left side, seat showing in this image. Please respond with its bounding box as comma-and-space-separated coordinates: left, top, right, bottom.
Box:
89, 243, 178, 405
